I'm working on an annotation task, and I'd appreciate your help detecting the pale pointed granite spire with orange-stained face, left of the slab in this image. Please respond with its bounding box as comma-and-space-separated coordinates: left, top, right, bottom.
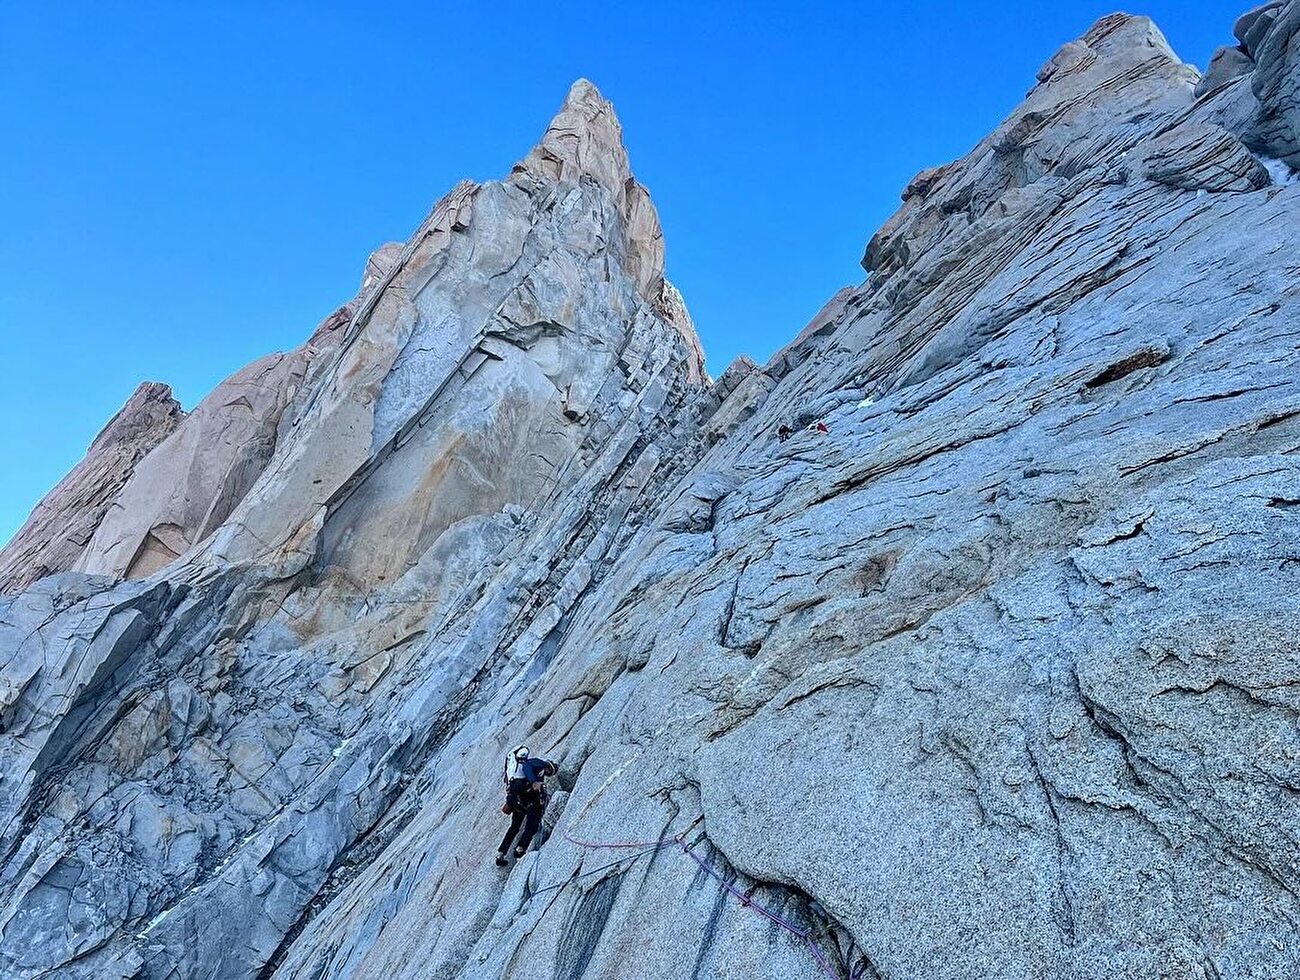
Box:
170, 81, 705, 587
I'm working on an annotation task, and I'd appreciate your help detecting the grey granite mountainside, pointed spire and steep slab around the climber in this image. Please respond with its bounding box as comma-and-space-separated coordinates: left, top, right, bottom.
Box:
0, 9, 1300, 980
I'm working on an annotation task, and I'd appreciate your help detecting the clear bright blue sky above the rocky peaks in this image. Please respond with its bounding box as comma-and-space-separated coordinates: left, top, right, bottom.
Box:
0, 0, 1249, 542
